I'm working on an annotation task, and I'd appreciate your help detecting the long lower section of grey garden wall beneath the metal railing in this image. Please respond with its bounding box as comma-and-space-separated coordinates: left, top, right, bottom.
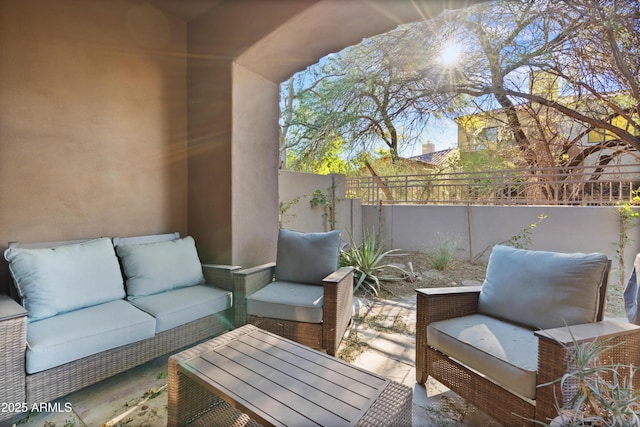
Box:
362, 205, 640, 283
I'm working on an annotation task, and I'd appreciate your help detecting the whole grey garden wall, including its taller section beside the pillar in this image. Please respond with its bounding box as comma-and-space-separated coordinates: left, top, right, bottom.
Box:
279, 171, 640, 283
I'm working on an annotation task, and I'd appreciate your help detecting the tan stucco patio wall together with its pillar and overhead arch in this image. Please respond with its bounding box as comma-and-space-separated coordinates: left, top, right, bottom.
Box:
0, 0, 470, 292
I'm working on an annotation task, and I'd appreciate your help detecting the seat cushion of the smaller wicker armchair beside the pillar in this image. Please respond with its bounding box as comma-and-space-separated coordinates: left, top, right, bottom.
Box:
247, 280, 324, 323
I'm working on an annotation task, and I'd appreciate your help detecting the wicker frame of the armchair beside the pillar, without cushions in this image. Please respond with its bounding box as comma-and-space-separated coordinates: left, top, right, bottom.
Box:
233, 263, 353, 356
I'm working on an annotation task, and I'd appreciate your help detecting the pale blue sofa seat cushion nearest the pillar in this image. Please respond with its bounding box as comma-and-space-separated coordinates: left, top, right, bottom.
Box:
131, 285, 232, 333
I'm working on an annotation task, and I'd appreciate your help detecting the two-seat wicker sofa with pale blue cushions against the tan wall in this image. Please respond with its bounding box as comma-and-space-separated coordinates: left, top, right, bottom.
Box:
0, 233, 236, 421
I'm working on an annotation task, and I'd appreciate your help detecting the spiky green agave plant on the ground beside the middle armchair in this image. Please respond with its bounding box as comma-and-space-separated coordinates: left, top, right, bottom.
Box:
340, 230, 409, 296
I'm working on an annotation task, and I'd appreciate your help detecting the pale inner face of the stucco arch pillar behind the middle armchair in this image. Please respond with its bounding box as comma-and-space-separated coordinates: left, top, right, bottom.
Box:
231, 64, 280, 265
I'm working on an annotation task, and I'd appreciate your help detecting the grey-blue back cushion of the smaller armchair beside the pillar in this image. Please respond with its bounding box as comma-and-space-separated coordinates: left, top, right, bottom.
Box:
275, 229, 340, 286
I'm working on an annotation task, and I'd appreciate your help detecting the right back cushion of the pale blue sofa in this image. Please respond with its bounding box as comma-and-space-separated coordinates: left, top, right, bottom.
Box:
116, 236, 204, 299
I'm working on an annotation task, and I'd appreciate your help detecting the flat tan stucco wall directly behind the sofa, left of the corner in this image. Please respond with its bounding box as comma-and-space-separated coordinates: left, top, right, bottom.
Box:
0, 0, 187, 287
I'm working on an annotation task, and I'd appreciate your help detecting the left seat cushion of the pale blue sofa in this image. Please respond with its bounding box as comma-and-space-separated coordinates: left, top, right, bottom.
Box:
26, 300, 155, 374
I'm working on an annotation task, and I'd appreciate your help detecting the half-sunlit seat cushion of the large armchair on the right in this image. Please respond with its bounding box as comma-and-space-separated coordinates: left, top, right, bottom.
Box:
427, 314, 538, 399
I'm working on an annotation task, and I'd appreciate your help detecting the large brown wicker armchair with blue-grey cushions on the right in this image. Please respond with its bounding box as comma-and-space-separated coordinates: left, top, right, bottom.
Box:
416, 245, 640, 426
